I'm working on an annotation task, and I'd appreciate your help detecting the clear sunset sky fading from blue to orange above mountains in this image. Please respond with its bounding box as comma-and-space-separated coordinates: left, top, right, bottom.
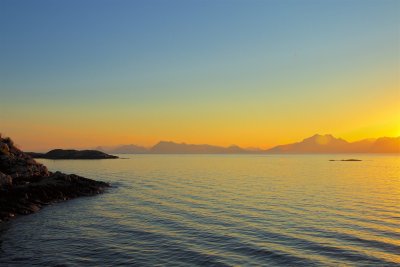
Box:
0, 0, 400, 151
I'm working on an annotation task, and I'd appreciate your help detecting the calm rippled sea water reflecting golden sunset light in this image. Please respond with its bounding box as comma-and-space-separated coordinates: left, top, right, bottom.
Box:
0, 155, 400, 266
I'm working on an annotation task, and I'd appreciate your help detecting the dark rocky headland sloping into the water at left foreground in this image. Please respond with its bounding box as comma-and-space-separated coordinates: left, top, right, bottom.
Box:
0, 135, 110, 222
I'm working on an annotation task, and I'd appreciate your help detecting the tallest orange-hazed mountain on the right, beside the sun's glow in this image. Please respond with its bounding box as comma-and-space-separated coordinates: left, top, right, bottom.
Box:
265, 134, 400, 154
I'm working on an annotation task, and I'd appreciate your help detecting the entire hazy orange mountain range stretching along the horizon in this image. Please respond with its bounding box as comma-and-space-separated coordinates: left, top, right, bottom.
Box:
95, 134, 400, 154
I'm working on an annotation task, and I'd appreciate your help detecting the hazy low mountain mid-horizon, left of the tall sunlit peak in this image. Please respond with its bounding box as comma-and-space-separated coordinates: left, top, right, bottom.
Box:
149, 141, 248, 154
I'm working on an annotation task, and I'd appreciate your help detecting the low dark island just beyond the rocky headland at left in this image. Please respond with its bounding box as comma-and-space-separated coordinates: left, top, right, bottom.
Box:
27, 149, 118, 159
